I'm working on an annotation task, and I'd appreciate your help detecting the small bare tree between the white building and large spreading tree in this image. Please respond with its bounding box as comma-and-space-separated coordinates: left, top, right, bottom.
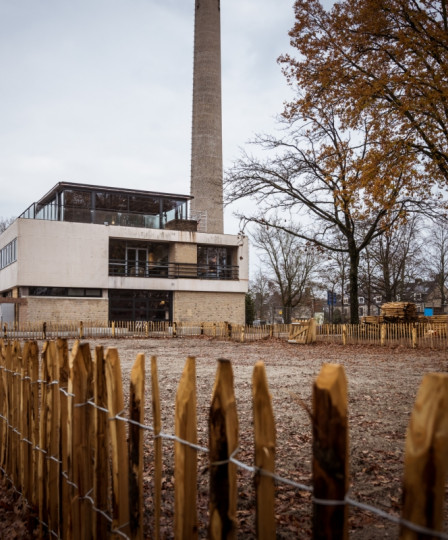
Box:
252, 220, 318, 323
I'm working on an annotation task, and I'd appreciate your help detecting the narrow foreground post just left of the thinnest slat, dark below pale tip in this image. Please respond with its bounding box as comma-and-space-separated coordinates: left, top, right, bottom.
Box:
129, 353, 145, 540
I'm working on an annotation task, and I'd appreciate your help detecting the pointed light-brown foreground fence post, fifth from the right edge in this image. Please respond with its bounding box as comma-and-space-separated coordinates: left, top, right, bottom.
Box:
174, 356, 198, 540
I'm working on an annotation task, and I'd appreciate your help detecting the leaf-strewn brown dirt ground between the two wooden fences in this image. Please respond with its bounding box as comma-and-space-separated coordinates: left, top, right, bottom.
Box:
0, 338, 448, 540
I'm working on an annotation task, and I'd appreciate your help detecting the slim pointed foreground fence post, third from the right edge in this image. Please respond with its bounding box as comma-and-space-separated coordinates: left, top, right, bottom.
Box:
252, 362, 275, 540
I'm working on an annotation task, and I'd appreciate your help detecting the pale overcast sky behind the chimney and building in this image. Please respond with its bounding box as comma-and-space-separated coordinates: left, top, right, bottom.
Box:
0, 0, 293, 233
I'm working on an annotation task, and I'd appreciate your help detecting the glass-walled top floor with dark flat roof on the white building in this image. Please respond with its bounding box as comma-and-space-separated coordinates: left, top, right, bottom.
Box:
20, 183, 191, 229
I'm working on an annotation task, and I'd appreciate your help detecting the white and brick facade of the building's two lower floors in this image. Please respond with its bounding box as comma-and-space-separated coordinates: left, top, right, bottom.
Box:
0, 186, 249, 323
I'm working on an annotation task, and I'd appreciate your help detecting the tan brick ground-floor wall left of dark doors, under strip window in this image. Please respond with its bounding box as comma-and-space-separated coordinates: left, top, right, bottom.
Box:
19, 297, 109, 323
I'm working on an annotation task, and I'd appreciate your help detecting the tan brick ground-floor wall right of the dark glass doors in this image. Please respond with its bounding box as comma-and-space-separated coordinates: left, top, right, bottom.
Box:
173, 292, 245, 324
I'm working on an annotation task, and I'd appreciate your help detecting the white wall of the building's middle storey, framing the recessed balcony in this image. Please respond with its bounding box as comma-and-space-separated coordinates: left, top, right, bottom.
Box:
0, 219, 249, 292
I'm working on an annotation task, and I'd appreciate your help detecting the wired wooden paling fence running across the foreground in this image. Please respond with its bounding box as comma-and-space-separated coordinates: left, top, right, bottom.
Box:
0, 339, 448, 540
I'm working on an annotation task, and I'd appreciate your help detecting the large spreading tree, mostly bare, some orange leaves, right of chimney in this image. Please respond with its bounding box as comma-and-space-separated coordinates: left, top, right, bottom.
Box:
226, 104, 425, 324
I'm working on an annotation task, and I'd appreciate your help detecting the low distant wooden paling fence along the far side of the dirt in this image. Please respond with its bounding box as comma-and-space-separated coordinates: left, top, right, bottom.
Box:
2, 321, 448, 349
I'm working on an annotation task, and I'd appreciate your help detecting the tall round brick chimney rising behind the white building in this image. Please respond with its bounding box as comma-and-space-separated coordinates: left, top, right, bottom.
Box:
191, 0, 224, 233
